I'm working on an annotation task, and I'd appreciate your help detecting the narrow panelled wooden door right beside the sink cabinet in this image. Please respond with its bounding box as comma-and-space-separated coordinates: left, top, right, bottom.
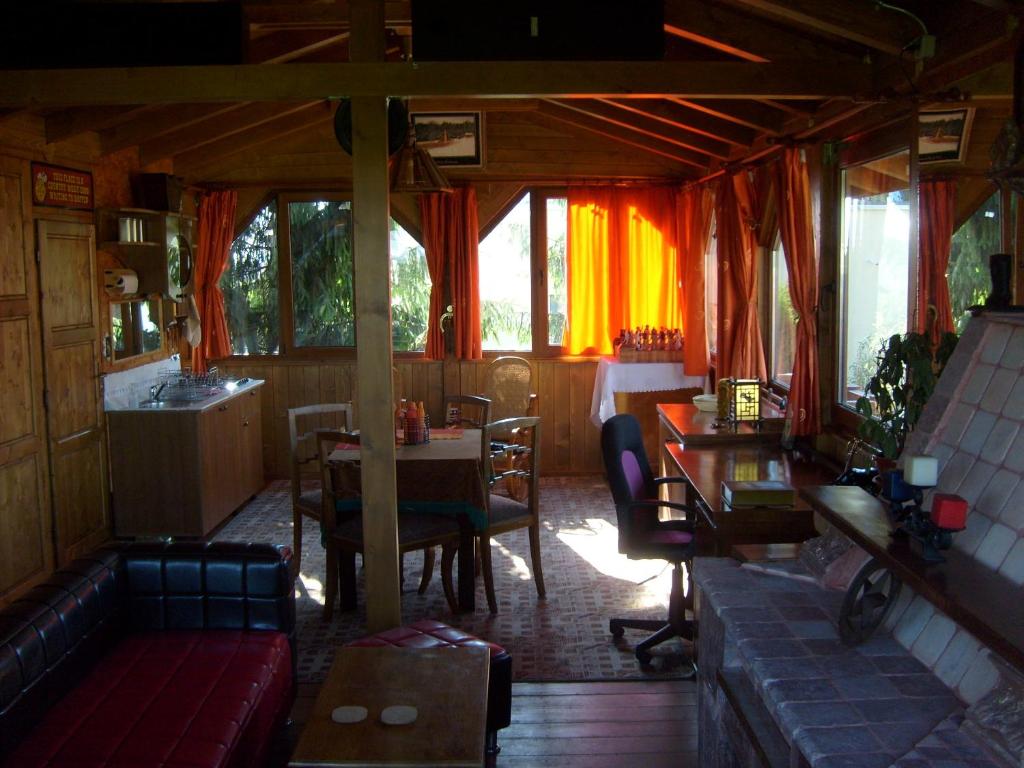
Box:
36, 220, 111, 563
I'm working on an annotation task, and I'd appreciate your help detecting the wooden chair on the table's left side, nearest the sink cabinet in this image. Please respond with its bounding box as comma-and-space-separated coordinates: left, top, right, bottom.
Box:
288, 402, 352, 577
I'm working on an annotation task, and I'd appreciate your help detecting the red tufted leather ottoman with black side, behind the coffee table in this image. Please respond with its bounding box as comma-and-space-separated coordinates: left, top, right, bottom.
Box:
348, 620, 512, 755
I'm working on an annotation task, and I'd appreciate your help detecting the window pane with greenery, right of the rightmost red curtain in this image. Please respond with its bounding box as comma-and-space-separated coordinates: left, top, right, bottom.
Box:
946, 193, 1001, 334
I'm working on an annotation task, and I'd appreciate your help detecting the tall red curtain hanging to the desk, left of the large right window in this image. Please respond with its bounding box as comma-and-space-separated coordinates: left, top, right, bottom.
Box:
775, 147, 821, 436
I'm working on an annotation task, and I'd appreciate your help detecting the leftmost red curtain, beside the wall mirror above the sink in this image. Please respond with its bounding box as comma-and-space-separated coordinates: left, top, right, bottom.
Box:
193, 189, 239, 373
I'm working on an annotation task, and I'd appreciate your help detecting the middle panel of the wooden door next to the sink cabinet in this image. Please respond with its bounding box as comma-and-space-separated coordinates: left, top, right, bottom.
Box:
46, 339, 100, 441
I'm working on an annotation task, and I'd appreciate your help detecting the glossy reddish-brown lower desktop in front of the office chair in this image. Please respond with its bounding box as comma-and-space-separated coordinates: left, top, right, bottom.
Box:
665, 442, 836, 511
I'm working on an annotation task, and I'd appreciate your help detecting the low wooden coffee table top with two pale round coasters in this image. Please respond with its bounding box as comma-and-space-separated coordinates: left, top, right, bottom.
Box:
289, 647, 490, 768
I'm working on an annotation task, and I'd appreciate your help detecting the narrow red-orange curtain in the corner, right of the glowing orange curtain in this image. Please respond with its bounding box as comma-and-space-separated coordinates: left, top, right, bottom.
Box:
677, 185, 715, 376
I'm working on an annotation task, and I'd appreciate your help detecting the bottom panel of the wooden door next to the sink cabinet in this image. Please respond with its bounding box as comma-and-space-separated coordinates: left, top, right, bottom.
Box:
53, 440, 109, 550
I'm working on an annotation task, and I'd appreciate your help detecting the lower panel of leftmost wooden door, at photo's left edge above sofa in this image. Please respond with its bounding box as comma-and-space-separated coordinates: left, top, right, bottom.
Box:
0, 454, 50, 594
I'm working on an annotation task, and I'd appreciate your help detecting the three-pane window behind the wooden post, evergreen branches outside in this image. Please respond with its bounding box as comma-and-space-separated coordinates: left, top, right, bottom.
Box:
220, 200, 430, 354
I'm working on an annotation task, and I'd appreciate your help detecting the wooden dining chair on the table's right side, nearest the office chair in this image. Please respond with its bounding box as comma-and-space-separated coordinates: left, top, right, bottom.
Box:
442, 416, 546, 613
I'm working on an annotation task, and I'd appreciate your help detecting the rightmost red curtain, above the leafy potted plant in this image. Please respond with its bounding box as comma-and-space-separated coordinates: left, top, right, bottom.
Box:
916, 179, 956, 344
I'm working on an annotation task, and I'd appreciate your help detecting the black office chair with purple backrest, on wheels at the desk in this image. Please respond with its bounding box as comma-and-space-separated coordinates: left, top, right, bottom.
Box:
601, 414, 695, 664
